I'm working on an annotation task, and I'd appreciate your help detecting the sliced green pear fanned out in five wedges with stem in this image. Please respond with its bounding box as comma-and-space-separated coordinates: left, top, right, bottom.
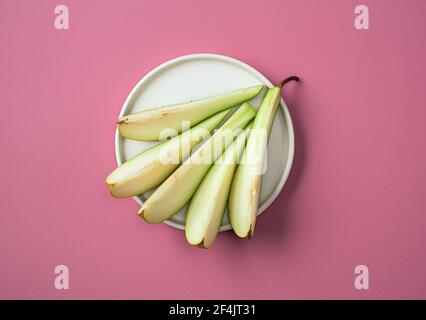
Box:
106, 77, 299, 248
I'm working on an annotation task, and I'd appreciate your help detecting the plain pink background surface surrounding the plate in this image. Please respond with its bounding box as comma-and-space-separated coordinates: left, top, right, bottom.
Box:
0, 0, 426, 299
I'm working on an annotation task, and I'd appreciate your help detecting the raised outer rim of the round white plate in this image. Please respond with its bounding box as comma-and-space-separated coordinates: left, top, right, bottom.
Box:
115, 53, 295, 232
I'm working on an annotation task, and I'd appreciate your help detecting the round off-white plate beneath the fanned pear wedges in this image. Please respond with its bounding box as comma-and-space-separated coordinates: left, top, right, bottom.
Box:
115, 54, 294, 231
